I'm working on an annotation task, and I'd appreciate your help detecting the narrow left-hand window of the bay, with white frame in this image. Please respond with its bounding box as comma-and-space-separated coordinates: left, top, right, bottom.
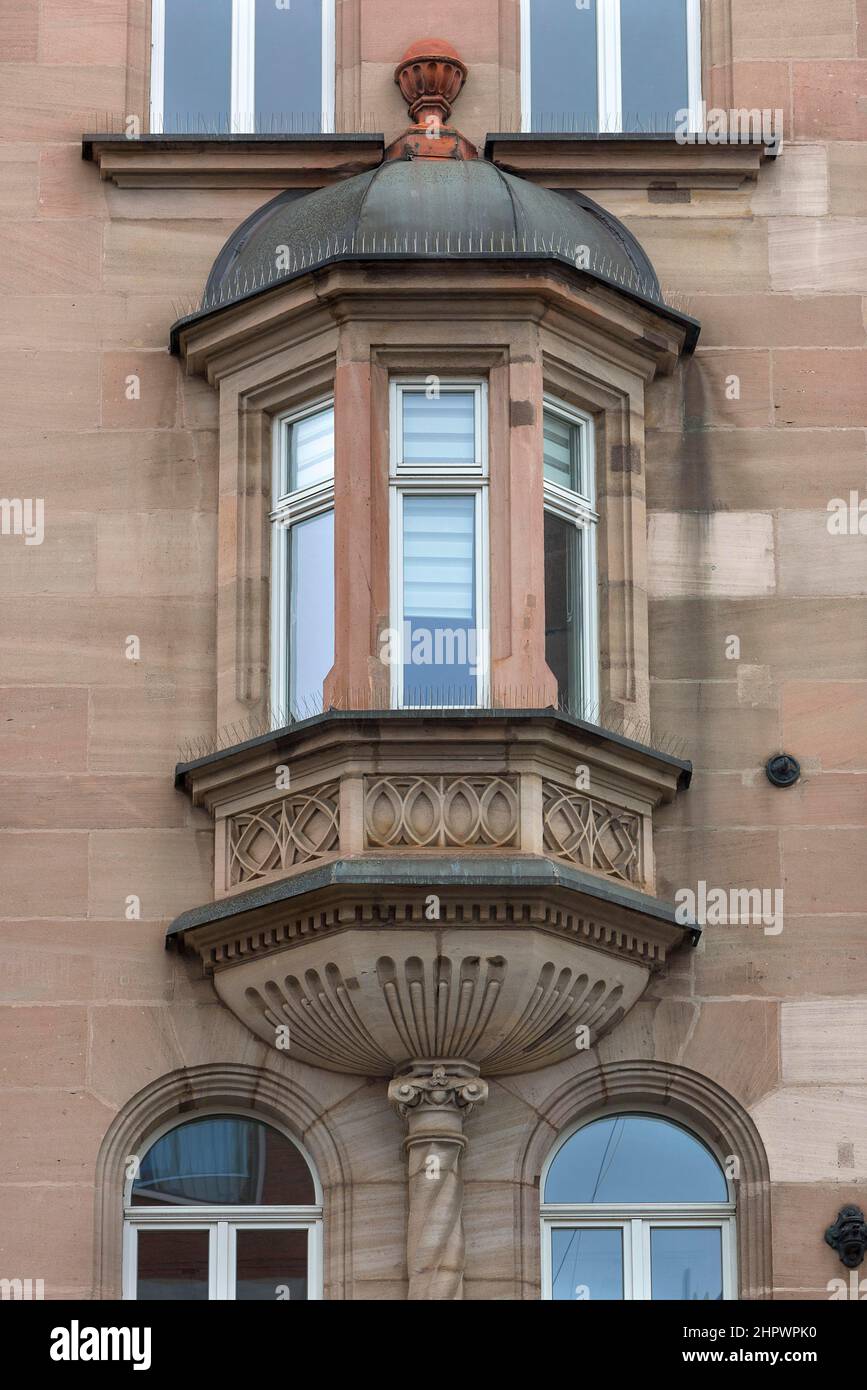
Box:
271, 402, 335, 723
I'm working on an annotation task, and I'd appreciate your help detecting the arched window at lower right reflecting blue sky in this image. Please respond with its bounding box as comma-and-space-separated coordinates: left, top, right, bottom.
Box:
542, 1115, 736, 1301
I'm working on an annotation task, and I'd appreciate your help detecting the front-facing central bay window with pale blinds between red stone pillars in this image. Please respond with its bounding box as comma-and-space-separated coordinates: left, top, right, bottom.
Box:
386, 378, 489, 709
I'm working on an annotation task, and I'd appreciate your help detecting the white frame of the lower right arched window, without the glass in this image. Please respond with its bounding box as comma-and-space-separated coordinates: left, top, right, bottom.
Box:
539, 1105, 738, 1302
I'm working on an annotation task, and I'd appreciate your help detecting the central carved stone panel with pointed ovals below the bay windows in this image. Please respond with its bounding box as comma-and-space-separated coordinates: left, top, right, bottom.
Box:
364, 776, 518, 849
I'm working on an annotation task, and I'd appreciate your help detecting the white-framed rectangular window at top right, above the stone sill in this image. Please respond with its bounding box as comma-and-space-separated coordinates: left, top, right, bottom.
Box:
521, 0, 702, 133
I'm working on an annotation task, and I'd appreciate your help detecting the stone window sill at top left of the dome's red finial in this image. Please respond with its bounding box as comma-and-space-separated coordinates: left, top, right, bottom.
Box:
82, 133, 385, 189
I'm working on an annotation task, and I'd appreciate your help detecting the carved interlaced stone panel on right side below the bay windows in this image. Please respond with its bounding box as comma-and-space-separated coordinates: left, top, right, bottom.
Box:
542, 781, 642, 883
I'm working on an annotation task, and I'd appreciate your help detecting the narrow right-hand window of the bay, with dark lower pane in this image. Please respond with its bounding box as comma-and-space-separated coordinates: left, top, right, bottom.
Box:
543, 399, 599, 720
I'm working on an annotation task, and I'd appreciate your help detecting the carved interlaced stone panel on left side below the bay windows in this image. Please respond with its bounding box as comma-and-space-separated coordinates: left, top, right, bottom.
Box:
226, 783, 340, 887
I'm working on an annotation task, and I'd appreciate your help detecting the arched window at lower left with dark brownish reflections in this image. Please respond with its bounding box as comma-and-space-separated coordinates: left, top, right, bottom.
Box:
124, 1115, 322, 1302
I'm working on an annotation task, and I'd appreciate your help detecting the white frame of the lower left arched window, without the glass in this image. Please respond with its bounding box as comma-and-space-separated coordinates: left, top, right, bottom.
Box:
121, 1105, 324, 1302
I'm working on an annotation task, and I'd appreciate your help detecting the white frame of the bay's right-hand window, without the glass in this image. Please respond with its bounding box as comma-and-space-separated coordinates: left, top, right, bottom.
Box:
543, 395, 599, 723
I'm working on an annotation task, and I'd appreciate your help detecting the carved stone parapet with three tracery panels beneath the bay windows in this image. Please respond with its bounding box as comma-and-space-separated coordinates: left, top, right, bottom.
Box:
178, 710, 689, 897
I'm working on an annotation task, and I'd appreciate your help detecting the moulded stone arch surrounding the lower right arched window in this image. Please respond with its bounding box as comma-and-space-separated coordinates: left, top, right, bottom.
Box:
517, 1062, 773, 1300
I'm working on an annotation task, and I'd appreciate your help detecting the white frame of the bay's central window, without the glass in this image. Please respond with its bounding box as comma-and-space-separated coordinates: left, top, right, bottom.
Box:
389, 377, 490, 709
